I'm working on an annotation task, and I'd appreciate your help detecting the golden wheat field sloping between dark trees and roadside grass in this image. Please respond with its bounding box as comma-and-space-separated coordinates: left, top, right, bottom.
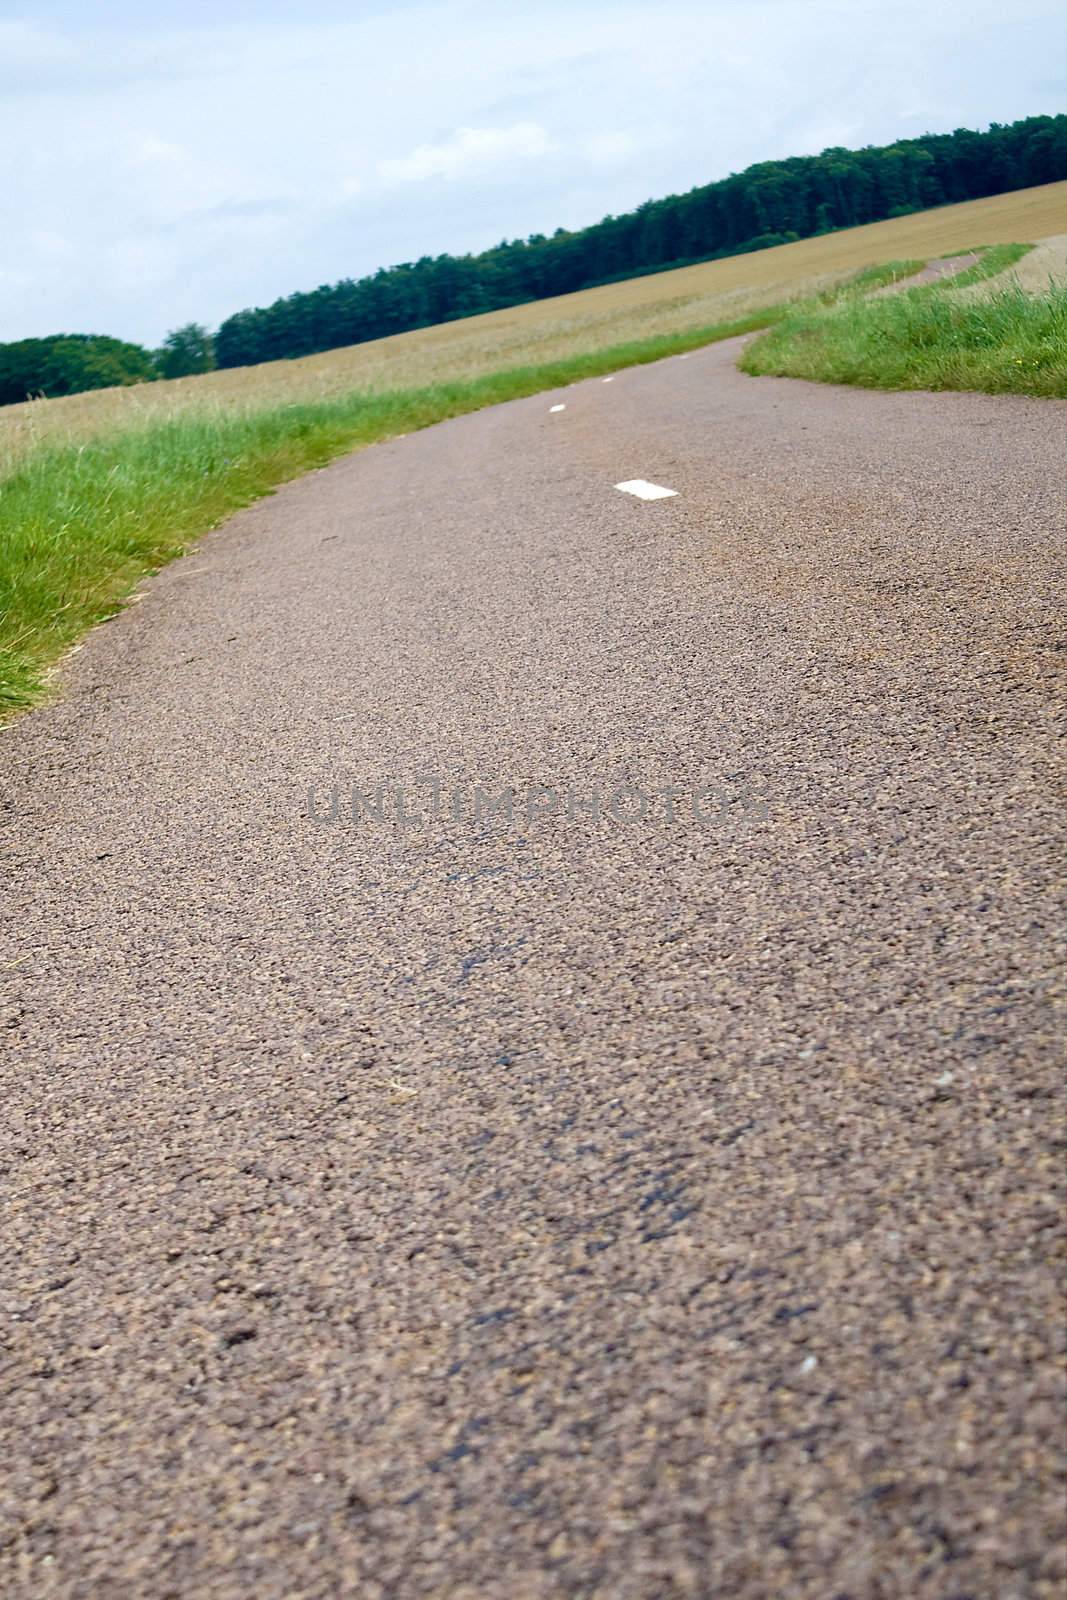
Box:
0, 182, 1067, 470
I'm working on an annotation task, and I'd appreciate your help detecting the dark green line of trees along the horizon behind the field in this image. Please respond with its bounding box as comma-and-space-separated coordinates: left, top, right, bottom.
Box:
0, 115, 1067, 405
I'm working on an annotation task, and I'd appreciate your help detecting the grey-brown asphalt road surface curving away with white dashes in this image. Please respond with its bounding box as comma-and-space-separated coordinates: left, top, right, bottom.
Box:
0, 346, 1067, 1600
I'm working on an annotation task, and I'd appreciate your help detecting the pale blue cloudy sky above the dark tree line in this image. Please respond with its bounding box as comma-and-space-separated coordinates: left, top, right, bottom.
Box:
0, 0, 1067, 346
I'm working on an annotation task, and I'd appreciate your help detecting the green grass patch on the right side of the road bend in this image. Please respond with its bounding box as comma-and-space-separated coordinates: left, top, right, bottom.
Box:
741, 245, 1067, 398
